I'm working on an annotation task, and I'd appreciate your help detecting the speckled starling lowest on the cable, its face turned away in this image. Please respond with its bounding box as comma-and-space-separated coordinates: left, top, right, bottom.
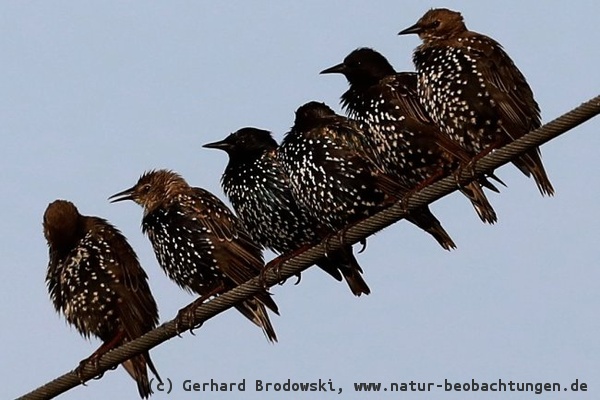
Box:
43, 200, 160, 398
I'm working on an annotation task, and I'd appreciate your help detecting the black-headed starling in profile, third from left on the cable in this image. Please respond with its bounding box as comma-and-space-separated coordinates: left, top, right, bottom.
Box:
204, 128, 371, 296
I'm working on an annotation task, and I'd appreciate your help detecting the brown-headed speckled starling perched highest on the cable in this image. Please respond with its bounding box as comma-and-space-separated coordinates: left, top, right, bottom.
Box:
399, 8, 554, 195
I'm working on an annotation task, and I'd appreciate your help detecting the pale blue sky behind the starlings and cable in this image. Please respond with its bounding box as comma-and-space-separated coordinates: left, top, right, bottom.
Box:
0, 0, 600, 399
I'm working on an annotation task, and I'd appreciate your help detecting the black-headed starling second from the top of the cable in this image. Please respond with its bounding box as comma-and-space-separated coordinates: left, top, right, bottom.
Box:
321, 48, 497, 223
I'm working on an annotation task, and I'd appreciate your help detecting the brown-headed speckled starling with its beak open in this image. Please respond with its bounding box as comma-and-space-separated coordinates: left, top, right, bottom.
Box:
110, 170, 279, 342
